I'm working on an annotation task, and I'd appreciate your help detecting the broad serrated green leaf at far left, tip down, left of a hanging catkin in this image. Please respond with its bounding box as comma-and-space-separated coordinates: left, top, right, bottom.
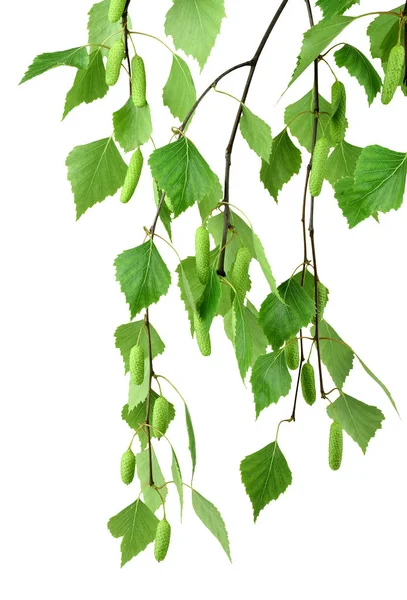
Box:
66, 137, 127, 219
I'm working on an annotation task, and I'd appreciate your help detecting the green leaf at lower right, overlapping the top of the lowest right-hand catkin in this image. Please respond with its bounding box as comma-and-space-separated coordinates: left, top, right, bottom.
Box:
327, 393, 384, 454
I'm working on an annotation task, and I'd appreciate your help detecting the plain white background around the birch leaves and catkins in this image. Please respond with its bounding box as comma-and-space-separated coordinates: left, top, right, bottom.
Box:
0, 0, 407, 600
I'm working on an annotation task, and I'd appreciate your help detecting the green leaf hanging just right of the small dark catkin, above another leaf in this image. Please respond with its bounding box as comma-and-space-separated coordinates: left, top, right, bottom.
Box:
311, 321, 353, 389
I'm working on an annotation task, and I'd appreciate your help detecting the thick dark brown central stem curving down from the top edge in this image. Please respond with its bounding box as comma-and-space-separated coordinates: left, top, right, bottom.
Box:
217, 0, 288, 277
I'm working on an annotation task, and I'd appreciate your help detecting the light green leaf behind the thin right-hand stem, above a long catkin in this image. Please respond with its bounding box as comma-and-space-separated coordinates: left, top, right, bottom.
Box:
284, 90, 335, 152
